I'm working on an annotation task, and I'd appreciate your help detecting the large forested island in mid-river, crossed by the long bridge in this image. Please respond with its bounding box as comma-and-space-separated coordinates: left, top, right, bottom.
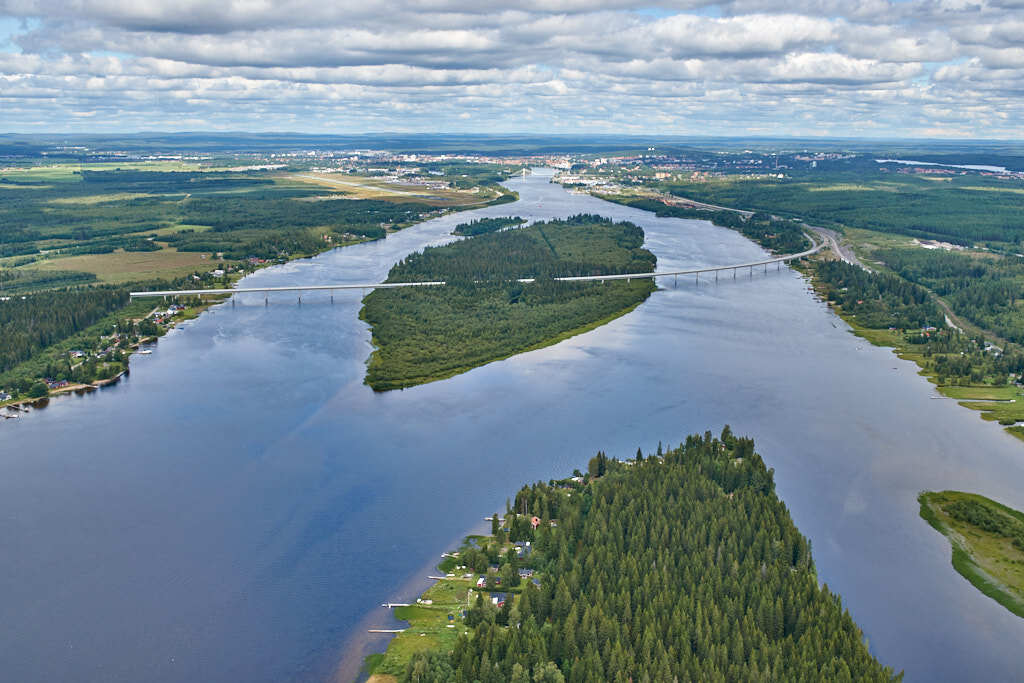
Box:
359, 215, 655, 391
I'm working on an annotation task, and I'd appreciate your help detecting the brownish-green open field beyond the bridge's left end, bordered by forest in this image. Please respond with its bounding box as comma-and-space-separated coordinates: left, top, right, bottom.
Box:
32, 247, 216, 285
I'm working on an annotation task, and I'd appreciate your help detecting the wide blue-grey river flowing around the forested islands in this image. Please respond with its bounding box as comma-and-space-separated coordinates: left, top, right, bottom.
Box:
0, 170, 1024, 683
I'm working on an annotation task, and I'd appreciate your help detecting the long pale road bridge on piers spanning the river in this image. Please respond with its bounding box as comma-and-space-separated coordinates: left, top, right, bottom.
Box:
131, 236, 827, 301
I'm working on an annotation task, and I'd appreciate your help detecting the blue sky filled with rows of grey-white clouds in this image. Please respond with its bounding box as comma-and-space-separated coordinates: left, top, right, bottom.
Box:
0, 0, 1024, 139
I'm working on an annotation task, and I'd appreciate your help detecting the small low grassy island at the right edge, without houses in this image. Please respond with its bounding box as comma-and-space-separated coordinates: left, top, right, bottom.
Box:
918, 490, 1024, 616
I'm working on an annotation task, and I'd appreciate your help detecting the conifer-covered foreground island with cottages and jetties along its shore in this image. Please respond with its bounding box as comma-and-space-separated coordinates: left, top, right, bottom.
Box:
368, 427, 902, 683
